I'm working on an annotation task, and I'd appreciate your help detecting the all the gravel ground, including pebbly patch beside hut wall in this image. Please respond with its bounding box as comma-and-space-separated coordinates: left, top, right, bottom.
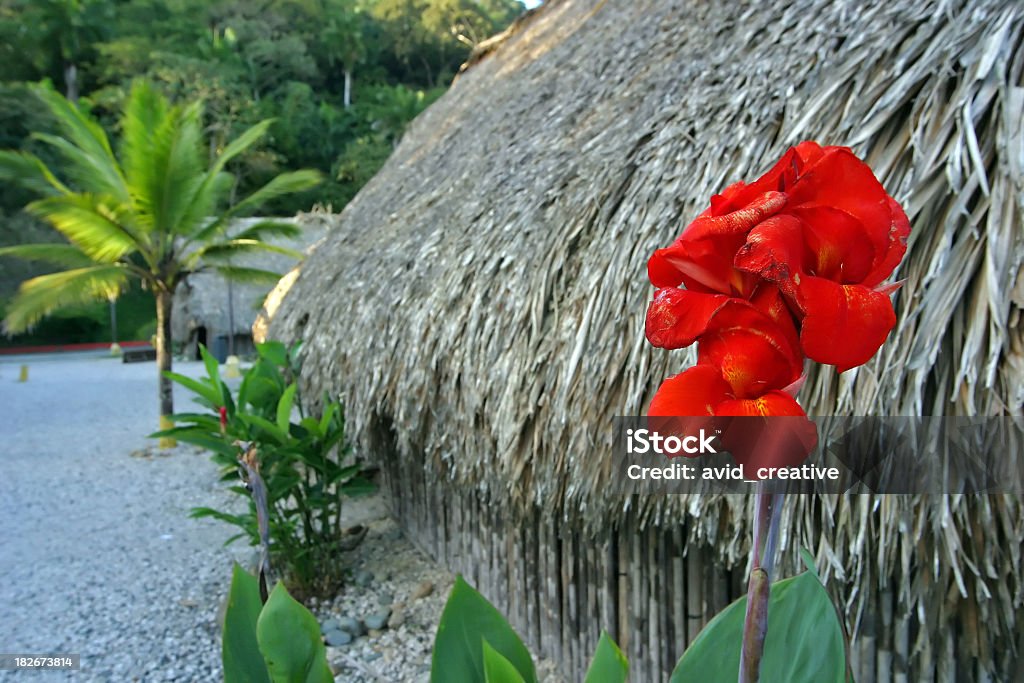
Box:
0, 353, 563, 683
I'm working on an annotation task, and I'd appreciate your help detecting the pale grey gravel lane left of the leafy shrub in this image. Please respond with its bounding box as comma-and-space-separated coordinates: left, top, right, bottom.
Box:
0, 352, 248, 682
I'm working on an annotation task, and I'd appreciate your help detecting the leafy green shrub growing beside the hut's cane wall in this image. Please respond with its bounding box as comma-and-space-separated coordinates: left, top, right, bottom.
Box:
154, 342, 374, 595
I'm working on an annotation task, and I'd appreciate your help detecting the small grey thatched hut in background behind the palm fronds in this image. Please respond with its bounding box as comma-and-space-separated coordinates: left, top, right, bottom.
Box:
171, 218, 324, 361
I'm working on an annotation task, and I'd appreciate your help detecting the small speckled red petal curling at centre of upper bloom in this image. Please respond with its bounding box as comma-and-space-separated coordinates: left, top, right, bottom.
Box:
734, 214, 807, 294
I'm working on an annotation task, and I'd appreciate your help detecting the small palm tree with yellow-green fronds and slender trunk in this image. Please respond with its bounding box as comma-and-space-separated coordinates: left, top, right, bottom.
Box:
0, 82, 319, 438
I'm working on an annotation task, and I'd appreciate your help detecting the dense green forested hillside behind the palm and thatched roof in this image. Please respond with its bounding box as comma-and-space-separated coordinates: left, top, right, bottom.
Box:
0, 0, 523, 229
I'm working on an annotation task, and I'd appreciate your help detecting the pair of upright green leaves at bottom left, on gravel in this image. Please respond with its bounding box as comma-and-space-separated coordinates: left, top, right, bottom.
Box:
222, 564, 334, 683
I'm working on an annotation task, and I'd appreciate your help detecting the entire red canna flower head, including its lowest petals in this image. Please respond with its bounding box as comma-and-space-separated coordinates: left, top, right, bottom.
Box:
645, 142, 910, 473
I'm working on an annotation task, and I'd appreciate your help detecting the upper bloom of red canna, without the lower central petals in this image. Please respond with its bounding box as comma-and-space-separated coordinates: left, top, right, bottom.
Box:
647, 142, 910, 372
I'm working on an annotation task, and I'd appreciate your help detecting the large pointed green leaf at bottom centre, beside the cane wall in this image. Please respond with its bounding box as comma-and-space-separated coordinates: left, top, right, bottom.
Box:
430, 575, 537, 683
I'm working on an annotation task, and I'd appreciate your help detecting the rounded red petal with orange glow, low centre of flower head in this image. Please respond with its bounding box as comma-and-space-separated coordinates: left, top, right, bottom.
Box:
697, 299, 804, 398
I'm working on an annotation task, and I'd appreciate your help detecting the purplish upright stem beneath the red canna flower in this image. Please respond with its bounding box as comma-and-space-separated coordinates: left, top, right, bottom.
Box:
739, 481, 783, 683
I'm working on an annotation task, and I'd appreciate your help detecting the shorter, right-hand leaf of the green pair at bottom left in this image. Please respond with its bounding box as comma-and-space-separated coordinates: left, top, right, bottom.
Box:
256, 582, 334, 683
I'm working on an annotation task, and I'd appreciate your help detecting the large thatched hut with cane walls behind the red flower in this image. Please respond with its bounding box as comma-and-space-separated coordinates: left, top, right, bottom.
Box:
268, 0, 1024, 682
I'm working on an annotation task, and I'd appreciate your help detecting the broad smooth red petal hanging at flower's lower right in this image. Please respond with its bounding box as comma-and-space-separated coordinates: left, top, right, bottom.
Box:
798, 278, 896, 373
